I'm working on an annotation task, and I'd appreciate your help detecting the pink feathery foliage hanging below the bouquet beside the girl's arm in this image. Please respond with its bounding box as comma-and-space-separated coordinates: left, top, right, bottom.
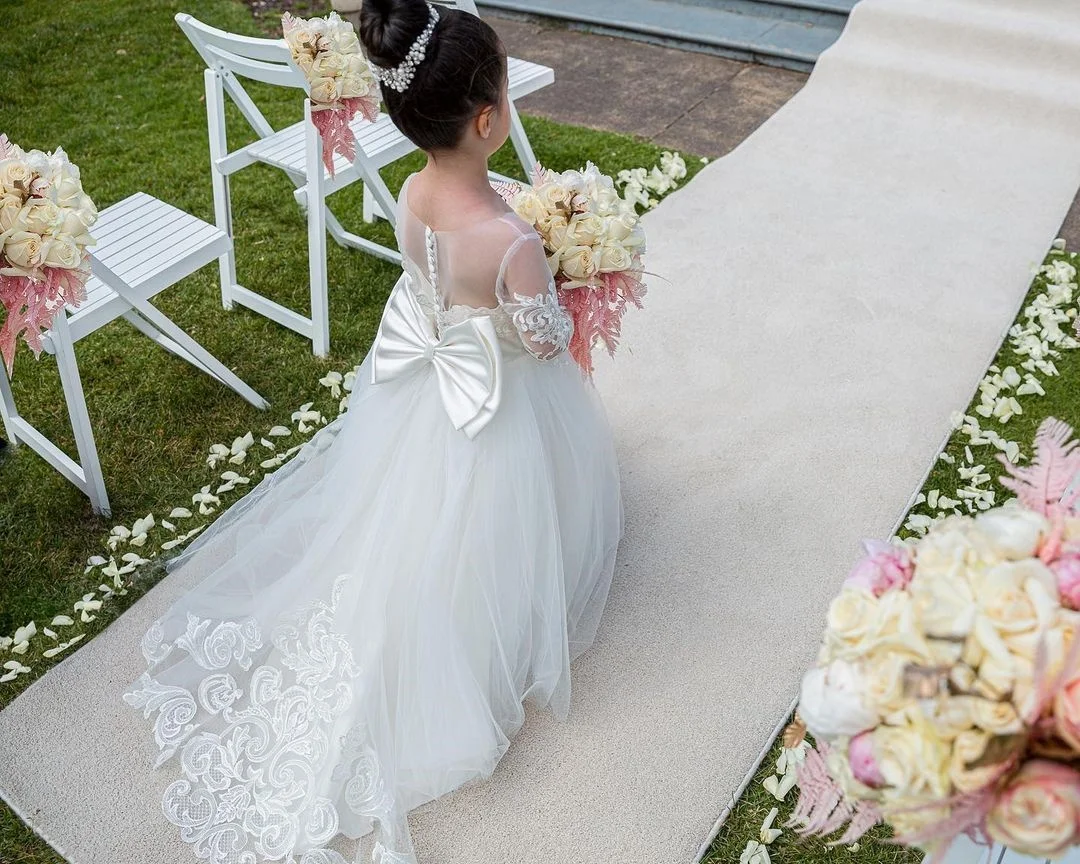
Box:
558, 264, 646, 376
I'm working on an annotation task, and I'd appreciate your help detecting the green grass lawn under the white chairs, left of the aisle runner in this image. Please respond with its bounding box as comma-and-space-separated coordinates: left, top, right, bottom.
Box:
0, 0, 701, 864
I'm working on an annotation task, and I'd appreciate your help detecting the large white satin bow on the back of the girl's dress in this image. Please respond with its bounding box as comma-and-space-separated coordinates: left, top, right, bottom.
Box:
372, 273, 502, 438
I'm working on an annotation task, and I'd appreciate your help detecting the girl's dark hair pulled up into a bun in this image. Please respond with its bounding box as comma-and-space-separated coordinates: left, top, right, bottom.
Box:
360, 0, 507, 151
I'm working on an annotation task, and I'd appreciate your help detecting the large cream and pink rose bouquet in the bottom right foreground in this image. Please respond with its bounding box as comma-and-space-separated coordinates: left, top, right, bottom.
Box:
787, 419, 1080, 859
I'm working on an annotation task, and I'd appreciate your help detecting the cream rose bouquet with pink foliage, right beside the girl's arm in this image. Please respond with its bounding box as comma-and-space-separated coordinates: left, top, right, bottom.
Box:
497, 162, 645, 375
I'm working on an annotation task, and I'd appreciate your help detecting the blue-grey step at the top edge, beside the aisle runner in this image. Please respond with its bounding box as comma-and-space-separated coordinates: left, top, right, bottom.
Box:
480, 0, 855, 70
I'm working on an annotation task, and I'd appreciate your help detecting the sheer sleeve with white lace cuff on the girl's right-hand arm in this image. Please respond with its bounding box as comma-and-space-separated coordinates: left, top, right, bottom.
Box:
496, 232, 573, 360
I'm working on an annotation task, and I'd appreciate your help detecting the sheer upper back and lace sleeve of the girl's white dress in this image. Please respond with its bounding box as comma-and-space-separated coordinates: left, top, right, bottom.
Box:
397, 177, 573, 360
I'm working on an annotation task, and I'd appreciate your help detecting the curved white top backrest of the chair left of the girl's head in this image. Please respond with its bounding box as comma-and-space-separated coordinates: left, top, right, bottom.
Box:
176, 12, 307, 90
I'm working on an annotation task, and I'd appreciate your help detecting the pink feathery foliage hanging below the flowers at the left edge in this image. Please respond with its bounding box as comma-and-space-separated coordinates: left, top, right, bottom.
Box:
0, 264, 90, 376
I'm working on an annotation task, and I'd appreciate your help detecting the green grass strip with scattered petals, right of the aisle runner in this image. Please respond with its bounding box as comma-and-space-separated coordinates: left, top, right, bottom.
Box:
704, 246, 1080, 864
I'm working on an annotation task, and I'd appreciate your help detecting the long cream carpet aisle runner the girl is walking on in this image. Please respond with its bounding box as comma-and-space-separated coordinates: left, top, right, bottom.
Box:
0, 0, 1080, 864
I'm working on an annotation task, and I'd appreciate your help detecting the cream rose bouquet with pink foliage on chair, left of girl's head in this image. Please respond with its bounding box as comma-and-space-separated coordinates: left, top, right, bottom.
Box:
281, 12, 380, 175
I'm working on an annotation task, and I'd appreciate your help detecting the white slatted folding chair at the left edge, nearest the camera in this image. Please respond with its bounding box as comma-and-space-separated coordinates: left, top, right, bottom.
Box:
0, 192, 269, 514
